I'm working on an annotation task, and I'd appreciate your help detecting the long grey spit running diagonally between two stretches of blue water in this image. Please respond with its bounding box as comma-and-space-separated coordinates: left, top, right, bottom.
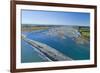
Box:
22, 35, 72, 61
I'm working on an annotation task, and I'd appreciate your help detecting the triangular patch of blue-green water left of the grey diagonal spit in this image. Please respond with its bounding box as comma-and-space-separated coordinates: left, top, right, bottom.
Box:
21, 40, 45, 63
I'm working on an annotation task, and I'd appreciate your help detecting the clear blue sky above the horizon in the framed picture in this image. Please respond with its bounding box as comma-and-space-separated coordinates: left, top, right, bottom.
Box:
21, 10, 90, 26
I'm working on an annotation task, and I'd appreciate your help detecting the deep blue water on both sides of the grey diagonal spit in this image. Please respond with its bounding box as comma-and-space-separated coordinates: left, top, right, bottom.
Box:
21, 30, 90, 62
